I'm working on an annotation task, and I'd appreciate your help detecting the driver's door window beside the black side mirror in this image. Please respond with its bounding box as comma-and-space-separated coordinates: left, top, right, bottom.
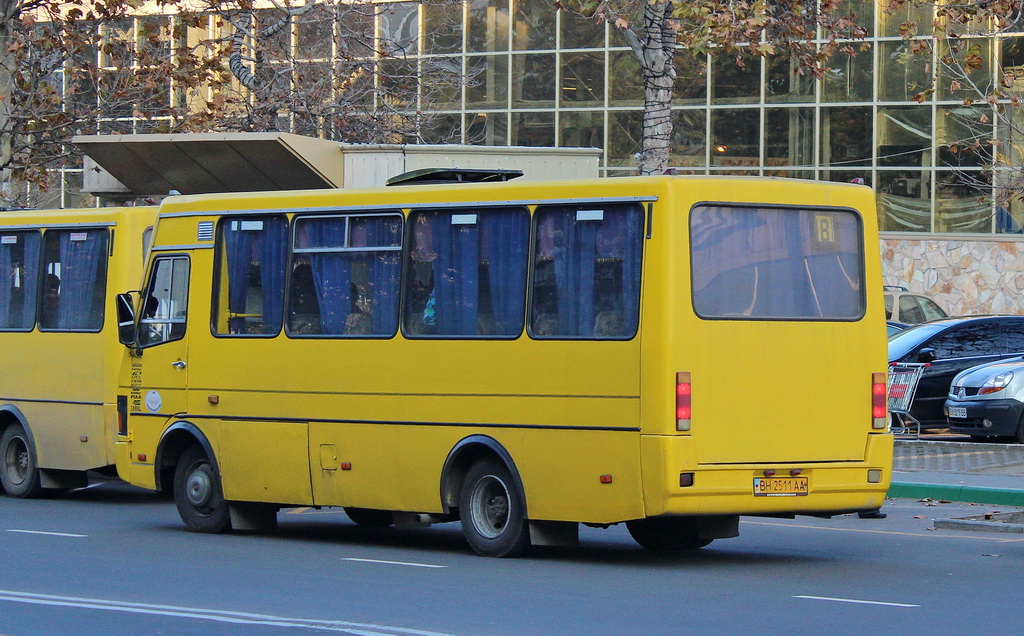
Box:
139, 256, 188, 346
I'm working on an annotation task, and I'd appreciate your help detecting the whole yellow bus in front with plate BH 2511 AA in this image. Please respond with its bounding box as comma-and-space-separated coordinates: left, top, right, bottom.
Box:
117, 176, 893, 556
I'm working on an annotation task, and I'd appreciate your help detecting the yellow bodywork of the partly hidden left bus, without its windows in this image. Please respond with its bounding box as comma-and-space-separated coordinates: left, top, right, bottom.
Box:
0, 207, 157, 487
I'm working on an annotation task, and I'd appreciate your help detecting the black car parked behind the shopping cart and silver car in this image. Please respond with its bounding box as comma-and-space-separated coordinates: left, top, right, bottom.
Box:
889, 315, 1024, 428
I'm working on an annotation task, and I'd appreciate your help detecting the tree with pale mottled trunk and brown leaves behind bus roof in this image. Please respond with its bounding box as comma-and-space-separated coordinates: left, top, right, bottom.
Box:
555, 0, 867, 174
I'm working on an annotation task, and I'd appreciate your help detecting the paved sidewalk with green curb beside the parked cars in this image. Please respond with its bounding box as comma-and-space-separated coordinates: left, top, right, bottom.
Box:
889, 439, 1024, 506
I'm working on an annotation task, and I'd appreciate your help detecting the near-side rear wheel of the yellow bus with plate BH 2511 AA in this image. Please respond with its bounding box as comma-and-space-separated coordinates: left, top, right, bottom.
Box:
459, 459, 529, 557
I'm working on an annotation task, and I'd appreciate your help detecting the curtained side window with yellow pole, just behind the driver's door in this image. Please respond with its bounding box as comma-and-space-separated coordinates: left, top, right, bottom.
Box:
213, 216, 288, 336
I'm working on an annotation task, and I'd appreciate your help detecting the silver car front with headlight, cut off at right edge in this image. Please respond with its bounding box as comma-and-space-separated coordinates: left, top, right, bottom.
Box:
943, 357, 1024, 443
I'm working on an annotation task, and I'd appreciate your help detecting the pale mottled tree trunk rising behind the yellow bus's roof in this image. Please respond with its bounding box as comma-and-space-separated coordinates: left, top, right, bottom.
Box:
637, 0, 676, 175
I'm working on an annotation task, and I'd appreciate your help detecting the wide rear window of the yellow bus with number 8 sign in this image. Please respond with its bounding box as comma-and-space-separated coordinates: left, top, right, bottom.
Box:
690, 205, 864, 321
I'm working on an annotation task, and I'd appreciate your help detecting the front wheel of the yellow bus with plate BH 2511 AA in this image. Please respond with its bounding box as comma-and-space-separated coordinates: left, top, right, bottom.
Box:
174, 446, 231, 534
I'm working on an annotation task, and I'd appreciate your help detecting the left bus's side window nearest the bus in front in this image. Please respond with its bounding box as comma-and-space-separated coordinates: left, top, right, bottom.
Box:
39, 229, 110, 331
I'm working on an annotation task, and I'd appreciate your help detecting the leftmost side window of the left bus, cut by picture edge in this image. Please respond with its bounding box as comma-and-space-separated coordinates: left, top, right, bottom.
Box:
0, 231, 40, 331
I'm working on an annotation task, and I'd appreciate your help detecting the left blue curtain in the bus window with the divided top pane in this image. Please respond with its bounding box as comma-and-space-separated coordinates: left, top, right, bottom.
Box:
307, 218, 352, 334
